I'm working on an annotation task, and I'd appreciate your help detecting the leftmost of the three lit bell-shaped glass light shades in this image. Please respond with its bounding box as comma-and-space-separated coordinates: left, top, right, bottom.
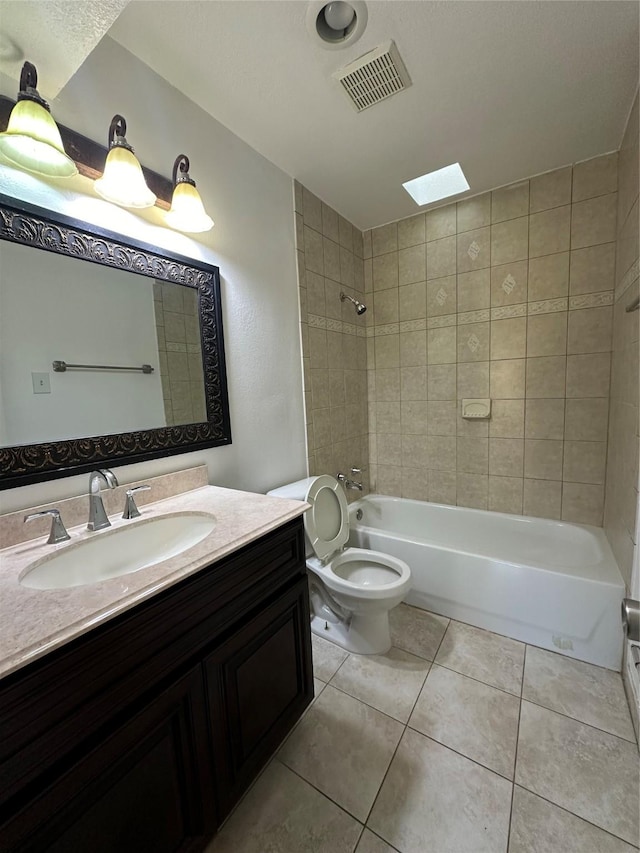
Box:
0, 98, 78, 178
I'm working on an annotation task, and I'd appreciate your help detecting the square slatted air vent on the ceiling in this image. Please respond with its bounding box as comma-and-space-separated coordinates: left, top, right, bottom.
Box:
333, 41, 411, 112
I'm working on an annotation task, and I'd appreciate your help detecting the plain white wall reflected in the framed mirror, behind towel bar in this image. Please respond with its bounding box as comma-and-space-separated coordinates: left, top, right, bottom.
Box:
0, 241, 165, 445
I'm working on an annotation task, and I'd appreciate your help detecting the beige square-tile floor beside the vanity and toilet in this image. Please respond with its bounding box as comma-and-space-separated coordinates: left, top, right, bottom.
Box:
207, 604, 640, 853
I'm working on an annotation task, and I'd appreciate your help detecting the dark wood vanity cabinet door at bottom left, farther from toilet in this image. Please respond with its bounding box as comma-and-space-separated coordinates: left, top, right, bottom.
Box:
0, 666, 217, 853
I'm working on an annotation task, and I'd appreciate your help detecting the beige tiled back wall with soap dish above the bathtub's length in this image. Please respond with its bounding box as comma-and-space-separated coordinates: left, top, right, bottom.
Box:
364, 153, 617, 525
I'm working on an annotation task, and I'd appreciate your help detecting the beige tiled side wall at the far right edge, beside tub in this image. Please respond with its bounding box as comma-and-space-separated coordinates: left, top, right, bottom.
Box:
604, 88, 640, 598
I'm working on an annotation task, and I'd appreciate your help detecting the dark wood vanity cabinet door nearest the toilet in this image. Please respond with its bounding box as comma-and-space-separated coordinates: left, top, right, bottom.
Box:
204, 578, 313, 820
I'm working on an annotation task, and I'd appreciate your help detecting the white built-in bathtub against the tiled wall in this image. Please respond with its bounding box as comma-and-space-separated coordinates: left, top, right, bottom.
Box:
349, 495, 624, 670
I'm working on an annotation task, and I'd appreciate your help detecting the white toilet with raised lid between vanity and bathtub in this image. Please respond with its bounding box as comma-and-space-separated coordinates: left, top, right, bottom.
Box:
268, 474, 411, 655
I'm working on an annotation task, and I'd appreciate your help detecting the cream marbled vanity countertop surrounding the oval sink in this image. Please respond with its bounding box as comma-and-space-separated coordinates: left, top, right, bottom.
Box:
0, 486, 308, 676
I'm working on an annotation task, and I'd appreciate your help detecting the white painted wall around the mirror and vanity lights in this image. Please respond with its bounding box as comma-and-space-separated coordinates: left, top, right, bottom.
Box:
0, 38, 306, 511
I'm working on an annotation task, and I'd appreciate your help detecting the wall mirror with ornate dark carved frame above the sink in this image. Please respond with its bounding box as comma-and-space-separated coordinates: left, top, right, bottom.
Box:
0, 195, 231, 488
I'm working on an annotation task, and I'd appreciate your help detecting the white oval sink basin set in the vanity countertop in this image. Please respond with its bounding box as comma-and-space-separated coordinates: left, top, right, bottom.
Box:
20, 513, 215, 589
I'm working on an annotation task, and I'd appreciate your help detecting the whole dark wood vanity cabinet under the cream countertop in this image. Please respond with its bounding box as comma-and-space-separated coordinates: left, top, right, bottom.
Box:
0, 519, 313, 853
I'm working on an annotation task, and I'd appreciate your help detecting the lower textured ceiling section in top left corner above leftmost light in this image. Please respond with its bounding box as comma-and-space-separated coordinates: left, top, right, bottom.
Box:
0, 0, 129, 99
